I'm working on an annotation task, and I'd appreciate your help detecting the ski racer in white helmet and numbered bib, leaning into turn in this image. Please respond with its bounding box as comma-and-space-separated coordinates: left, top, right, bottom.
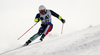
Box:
24, 5, 65, 46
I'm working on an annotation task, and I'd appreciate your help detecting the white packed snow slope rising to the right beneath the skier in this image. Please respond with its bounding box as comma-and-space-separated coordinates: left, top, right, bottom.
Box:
0, 25, 100, 55
